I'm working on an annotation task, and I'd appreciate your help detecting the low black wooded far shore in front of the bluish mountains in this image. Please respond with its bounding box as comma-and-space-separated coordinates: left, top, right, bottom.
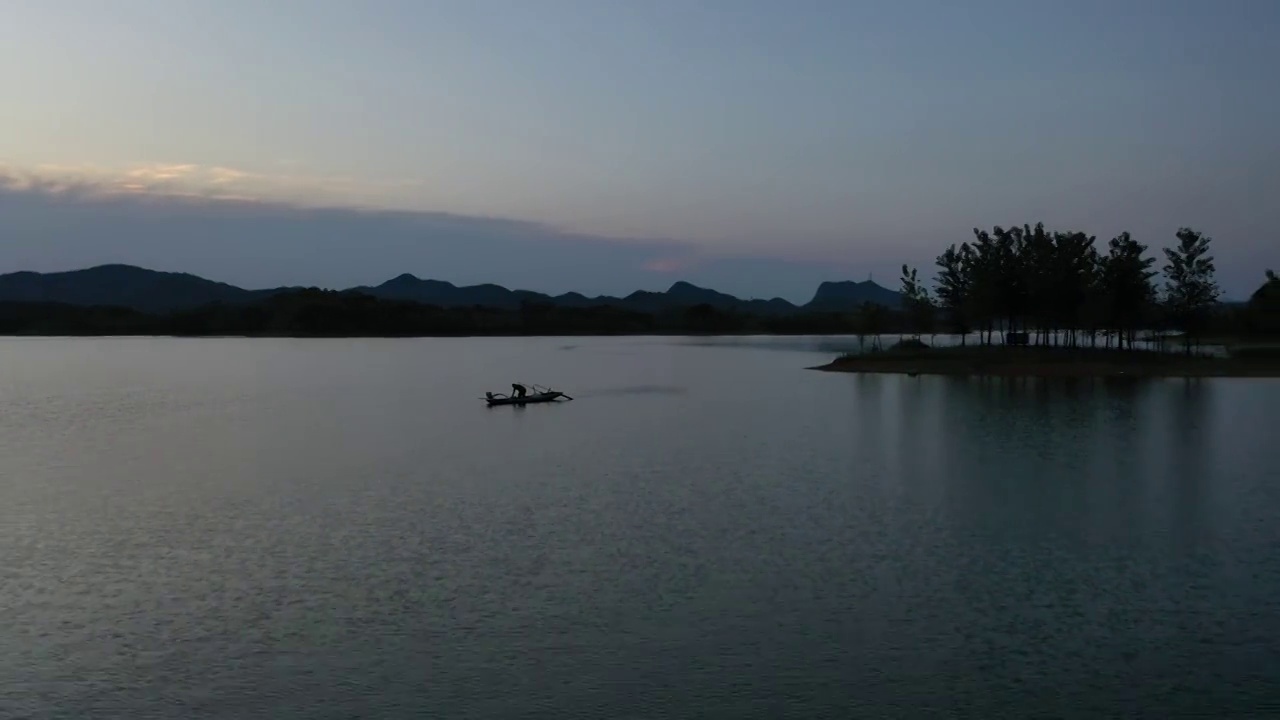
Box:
0, 275, 1280, 342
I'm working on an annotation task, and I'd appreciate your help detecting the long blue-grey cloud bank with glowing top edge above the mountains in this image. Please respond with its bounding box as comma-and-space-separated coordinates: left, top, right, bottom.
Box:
0, 164, 865, 300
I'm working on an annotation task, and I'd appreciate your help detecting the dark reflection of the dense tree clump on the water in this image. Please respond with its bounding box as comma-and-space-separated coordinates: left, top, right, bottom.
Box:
940, 378, 1153, 537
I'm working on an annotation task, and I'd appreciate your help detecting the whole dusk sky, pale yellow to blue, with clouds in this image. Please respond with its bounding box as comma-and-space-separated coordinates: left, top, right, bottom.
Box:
0, 0, 1280, 300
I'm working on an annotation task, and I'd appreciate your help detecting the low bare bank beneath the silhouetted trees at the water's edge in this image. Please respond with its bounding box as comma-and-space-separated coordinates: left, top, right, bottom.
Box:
813, 346, 1280, 378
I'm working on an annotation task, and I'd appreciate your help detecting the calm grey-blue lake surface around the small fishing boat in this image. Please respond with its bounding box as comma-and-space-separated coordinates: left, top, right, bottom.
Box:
0, 337, 1280, 720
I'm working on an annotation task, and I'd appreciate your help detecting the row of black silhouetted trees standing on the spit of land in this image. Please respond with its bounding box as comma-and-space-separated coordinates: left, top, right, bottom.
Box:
901, 223, 1277, 352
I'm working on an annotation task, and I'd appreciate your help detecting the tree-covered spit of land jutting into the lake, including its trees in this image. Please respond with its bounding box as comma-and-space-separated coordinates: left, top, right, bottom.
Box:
814, 224, 1280, 378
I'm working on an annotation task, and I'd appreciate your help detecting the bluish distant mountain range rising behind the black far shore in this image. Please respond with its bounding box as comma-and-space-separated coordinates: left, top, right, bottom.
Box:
0, 265, 901, 316
